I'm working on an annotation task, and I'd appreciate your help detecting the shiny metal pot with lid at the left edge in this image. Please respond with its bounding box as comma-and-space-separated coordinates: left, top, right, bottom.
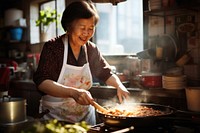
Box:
0, 95, 26, 125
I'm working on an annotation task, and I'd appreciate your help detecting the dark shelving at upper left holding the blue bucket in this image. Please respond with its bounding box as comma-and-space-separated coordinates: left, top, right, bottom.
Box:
0, 0, 30, 63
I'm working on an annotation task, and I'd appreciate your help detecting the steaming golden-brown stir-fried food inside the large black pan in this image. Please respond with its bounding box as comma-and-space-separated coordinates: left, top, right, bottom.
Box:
103, 106, 165, 117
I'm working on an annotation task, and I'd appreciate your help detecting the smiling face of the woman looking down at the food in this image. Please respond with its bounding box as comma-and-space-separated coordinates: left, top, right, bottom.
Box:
69, 17, 95, 46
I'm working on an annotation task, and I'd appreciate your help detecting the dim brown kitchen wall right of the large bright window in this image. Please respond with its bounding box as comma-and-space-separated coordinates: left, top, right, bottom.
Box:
146, 0, 200, 85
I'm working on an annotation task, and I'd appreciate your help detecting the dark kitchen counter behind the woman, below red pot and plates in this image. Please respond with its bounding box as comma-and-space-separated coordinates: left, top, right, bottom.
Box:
90, 86, 187, 110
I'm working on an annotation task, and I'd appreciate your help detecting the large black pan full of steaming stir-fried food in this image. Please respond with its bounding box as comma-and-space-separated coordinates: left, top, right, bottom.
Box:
97, 103, 180, 127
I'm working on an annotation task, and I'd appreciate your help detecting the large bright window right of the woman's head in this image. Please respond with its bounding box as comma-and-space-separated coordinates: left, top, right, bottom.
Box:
95, 0, 143, 55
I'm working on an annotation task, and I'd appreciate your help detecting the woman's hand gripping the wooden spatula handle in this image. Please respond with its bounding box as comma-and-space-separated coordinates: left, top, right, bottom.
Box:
72, 89, 94, 105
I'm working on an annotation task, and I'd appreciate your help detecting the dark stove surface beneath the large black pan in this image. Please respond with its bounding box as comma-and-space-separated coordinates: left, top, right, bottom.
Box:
88, 112, 200, 133
